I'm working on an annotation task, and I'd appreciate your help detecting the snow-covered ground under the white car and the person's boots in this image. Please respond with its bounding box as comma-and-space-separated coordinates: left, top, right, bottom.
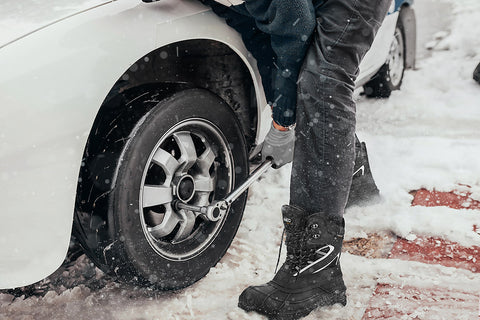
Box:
0, 0, 480, 320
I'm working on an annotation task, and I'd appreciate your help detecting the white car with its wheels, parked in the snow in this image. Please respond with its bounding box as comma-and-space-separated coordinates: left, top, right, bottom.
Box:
0, 0, 415, 289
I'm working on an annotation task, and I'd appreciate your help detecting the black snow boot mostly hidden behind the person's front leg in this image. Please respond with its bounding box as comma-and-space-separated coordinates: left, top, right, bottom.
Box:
347, 141, 380, 207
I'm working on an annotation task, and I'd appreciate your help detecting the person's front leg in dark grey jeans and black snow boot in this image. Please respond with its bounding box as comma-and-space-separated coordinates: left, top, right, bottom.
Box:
239, 0, 390, 319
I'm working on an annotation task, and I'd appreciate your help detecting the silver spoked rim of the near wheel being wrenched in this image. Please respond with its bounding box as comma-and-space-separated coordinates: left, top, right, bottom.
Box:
139, 119, 234, 260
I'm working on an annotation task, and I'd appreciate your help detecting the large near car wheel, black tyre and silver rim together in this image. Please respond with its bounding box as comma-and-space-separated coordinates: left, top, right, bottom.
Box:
80, 89, 248, 289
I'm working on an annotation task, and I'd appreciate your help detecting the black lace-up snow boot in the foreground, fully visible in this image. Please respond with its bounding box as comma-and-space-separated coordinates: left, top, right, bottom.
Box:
238, 206, 347, 320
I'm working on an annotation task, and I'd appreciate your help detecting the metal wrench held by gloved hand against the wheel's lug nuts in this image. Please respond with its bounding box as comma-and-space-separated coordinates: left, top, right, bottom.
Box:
173, 160, 272, 221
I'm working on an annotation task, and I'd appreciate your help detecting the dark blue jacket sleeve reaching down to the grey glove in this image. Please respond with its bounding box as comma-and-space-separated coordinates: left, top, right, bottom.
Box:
242, 0, 316, 126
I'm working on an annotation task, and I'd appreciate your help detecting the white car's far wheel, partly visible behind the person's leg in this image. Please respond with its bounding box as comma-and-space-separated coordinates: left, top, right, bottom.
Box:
363, 15, 406, 98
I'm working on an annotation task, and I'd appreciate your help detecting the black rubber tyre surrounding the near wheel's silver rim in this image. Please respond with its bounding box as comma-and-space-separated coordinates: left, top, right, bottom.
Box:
109, 89, 248, 289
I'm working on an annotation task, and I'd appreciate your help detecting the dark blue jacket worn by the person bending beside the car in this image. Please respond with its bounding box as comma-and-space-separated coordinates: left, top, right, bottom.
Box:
202, 0, 323, 126
